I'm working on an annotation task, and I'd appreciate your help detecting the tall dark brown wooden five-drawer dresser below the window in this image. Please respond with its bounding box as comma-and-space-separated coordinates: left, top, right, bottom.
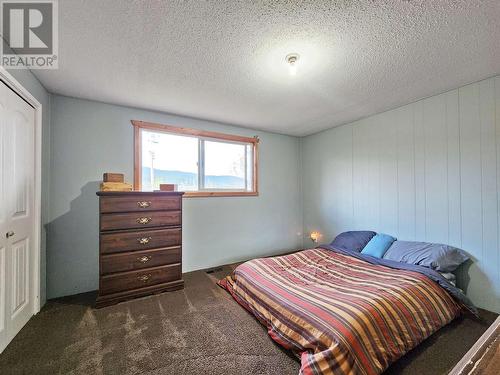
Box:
96, 191, 184, 307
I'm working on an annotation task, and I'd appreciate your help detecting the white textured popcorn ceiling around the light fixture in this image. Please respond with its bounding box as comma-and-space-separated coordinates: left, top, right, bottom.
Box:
34, 0, 500, 135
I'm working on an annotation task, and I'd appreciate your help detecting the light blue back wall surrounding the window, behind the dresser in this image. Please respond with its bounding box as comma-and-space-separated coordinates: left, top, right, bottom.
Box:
47, 95, 302, 297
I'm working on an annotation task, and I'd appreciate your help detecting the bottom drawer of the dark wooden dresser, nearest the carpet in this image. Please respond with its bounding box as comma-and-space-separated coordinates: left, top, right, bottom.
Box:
99, 264, 181, 294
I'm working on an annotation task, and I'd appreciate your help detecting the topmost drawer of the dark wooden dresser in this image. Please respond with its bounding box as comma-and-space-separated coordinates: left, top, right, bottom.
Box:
100, 195, 182, 213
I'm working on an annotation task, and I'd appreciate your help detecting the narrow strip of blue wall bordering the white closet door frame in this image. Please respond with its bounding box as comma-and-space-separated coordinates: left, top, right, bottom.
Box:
9, 69, 51, 306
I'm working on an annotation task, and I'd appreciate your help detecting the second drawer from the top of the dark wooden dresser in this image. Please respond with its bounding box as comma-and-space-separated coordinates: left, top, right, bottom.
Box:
101, 211, 181, 230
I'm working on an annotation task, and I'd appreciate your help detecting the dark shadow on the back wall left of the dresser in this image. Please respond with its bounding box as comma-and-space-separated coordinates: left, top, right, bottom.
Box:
45, 181, 100, 298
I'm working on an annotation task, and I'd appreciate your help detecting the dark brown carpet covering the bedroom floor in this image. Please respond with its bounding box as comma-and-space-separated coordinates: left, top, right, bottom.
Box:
0, 266, 496, 375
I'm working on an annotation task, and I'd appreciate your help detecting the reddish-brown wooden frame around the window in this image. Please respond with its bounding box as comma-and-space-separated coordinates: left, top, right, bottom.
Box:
131, 120, 259, 197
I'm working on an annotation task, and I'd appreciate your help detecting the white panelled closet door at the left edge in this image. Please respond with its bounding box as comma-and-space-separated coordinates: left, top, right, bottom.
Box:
0, 82, 35, 353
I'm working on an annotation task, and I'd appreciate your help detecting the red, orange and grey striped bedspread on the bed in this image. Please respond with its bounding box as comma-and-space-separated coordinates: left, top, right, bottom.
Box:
219, 248, 462, 375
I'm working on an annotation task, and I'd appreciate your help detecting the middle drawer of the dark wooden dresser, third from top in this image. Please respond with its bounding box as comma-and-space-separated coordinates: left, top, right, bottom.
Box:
100, 228, 182, 254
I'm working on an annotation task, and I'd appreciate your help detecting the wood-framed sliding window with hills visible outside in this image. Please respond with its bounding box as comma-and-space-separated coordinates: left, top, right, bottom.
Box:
132, 121, 259, 197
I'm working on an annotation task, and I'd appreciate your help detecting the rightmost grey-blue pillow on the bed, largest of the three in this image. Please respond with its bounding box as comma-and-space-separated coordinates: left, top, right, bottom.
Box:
383, 241, 469, 272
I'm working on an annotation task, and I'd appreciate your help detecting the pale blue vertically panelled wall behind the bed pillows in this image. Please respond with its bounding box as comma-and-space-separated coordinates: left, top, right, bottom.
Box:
302, 77, 500, 312
